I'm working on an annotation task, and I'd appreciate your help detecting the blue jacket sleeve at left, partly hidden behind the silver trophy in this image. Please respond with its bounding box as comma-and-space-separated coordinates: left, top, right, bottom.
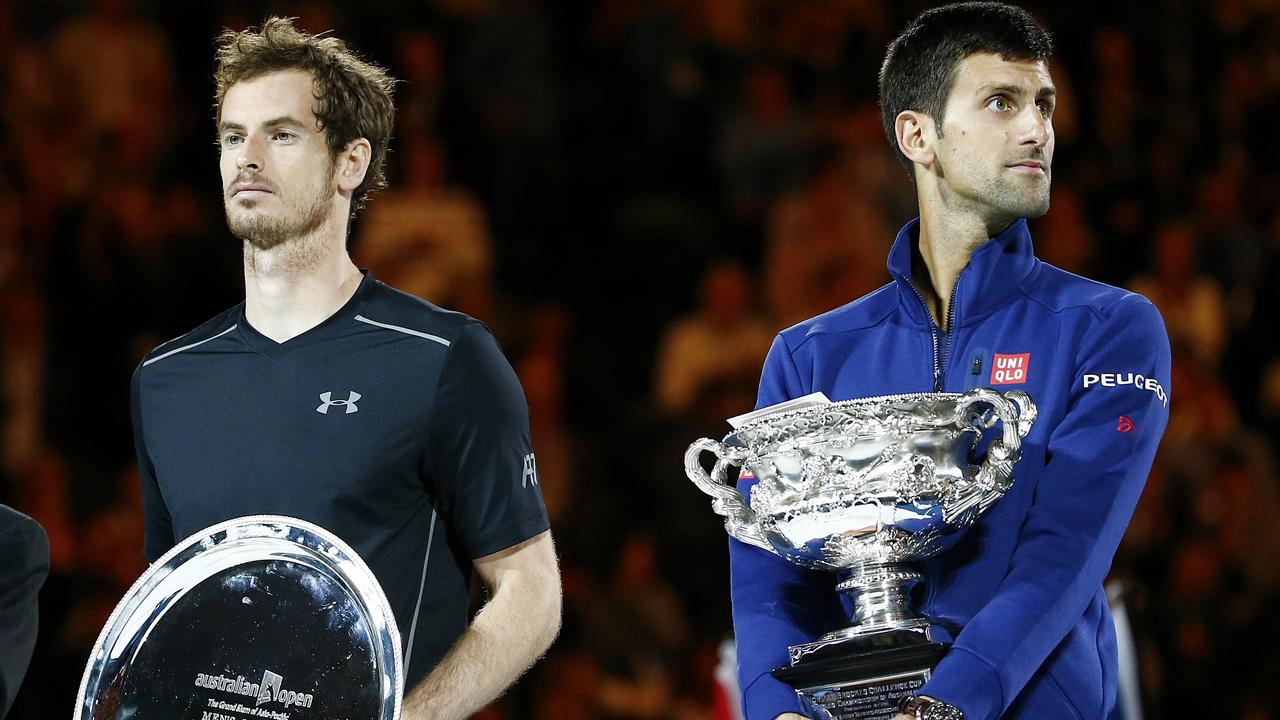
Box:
728, 336, 836, 720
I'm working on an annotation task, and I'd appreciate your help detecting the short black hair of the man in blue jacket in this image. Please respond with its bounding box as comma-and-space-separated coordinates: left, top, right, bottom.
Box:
879, 3, 1053, 172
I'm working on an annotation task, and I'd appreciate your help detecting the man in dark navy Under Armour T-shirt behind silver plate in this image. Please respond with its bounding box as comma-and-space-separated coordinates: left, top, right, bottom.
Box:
133, 18, 561, 719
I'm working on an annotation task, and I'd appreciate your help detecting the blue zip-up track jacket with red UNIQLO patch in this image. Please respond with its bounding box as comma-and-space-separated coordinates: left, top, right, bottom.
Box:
730, 220, 1170, 720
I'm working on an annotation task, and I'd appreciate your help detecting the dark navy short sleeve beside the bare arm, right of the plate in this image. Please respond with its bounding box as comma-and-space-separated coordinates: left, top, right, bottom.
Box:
428, 323, 549, 559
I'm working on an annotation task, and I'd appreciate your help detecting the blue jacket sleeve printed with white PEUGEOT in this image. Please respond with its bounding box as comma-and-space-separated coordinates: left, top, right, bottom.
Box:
920, 295, 1170, 720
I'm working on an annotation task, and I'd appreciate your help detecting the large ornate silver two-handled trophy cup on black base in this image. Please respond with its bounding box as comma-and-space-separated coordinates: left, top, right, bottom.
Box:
685, 388, 1036, 719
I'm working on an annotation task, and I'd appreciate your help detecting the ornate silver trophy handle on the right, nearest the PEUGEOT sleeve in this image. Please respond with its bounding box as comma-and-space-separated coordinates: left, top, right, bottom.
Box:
947, 387, 1037, 519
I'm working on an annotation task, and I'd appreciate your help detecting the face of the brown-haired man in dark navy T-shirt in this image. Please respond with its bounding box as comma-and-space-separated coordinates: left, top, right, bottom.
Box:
218, 70, 338, 250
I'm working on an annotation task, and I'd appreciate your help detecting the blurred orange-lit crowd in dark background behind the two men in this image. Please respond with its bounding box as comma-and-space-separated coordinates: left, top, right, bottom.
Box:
0, 0, 1280, 720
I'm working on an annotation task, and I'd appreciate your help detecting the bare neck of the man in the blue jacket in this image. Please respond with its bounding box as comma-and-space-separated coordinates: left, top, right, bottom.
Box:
911, 185, 1009, 332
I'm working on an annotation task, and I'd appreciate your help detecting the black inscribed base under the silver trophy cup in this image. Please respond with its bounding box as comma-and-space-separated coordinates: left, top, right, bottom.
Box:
773, 628, 947, 720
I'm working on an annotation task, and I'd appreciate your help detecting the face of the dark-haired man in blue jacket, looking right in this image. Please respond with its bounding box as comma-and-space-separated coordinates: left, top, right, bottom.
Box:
937, 53, 1055, 220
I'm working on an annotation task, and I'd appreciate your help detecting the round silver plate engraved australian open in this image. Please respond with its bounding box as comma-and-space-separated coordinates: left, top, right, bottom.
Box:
74, 515, 403, 720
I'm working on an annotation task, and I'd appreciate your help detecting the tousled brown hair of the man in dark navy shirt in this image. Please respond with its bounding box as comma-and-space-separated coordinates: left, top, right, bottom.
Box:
214, 17, 396, 214
